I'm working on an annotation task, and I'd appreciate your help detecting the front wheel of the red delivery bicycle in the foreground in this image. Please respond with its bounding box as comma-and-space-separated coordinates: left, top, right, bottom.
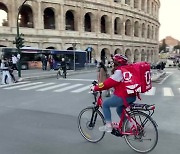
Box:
78, 107, 105, 143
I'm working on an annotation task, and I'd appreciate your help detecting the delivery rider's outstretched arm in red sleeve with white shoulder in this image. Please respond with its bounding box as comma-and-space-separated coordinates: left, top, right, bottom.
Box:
94, 70, 123, 91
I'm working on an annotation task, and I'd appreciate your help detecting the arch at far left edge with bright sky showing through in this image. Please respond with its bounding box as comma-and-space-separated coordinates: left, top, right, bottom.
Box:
0, 2, 9, 26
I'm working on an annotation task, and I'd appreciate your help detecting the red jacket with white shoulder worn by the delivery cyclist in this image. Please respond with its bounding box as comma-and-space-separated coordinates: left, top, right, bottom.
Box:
94, 67, 134, 98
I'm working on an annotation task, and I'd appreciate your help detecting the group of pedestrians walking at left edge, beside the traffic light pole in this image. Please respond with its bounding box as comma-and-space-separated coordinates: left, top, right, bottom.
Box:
0, 55, 18, 84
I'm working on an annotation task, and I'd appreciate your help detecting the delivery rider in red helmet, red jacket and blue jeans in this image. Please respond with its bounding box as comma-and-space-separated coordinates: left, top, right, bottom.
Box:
91, 54, 136, 132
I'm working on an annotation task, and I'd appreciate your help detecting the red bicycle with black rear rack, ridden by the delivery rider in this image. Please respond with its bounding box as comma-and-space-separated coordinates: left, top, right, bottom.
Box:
78, 82, 158, 153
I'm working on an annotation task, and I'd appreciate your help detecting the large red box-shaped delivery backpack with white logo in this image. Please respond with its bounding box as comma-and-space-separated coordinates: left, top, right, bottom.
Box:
121, 62, 152, 94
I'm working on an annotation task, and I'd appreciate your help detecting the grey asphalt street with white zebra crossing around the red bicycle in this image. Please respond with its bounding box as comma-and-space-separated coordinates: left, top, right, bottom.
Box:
0, 69, 180, 154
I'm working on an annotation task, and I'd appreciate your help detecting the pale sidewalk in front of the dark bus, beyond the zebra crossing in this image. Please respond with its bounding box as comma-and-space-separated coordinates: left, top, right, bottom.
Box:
3, 68, 166, 81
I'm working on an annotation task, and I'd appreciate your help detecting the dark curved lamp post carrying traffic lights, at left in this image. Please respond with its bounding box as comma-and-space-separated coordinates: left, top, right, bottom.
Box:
15, 0, 28, 78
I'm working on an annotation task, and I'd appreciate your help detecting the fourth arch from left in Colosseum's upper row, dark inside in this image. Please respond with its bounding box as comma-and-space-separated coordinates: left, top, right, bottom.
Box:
65, 11, 75, 31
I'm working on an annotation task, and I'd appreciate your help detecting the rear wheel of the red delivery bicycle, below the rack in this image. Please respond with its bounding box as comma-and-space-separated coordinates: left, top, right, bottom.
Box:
123, 112, 158, 153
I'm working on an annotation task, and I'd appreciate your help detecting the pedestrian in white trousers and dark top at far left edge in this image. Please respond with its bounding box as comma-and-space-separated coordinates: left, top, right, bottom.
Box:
1, 58, 12, 84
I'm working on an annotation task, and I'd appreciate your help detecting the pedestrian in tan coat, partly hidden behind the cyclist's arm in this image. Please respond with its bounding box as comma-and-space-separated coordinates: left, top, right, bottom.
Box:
97, 61, 110, 97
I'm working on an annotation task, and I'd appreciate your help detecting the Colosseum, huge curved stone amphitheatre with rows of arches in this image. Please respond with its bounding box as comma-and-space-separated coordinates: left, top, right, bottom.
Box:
0, 0, 160, 62
